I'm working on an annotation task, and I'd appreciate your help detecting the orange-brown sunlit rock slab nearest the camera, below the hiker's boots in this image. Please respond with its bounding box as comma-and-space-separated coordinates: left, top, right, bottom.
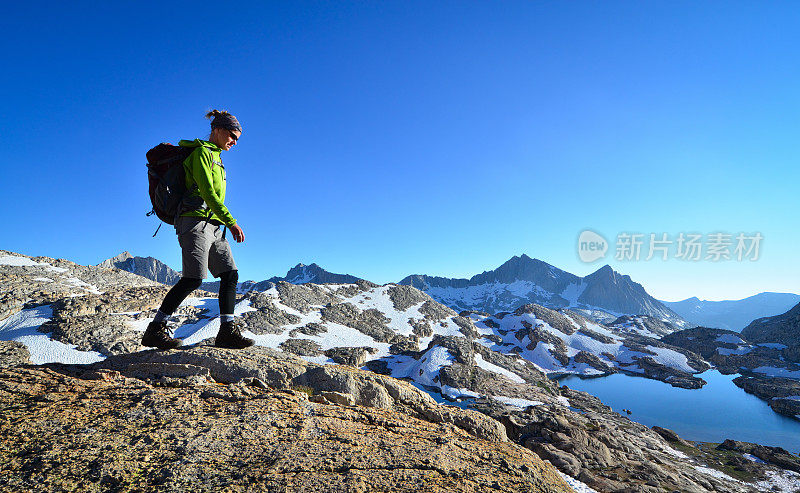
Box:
0, 356, 571, 493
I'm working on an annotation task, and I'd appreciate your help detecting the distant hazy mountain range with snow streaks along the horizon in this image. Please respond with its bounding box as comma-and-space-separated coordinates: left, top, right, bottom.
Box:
98, 252, 800, 331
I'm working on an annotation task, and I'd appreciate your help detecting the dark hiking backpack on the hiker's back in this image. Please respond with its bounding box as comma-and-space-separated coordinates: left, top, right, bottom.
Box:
147, 143, 195, 236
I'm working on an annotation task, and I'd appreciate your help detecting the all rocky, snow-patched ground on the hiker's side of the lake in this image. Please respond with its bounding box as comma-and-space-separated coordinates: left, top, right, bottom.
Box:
0, 252, 800, 493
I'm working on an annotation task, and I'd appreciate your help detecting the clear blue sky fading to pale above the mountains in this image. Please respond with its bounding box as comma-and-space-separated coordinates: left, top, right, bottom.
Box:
0, 0, 800, 300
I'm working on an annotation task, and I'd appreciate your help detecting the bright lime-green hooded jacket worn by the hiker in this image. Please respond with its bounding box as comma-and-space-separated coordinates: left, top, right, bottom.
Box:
178, 139, 236, 227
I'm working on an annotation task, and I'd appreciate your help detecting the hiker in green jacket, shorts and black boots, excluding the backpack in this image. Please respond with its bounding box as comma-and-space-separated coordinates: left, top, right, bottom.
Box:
142, 110, 253, 349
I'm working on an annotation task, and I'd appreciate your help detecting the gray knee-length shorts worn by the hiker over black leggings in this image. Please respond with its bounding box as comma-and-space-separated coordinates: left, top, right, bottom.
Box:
175, 216, 236, 279
